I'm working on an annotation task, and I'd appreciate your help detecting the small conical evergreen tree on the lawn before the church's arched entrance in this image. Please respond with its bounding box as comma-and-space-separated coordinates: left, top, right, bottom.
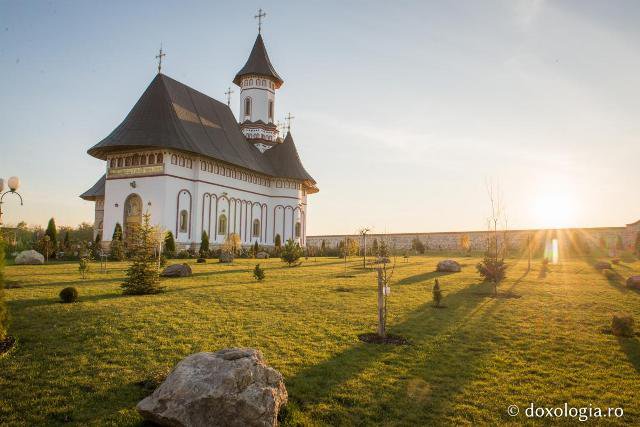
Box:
121, 213, 164, 295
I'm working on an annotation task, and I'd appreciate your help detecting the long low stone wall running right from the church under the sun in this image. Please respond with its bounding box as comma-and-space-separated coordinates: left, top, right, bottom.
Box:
307, 221, 640, 251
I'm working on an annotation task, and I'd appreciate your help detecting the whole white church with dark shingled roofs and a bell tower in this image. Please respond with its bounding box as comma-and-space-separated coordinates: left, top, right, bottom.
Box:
80, 25, 318, 248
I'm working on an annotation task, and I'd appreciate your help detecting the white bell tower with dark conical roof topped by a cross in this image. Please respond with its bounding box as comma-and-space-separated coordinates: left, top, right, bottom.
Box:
233, 10, 284, 151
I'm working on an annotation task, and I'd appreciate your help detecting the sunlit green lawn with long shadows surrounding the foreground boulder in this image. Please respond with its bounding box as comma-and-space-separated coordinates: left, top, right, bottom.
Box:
0, 257, 640, 425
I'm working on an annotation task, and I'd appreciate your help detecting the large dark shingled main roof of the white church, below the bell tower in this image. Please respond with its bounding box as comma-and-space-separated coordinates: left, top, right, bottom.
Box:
88, 74, 315, 185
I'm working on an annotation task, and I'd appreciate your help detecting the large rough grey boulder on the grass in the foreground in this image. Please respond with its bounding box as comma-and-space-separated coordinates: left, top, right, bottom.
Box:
137, 348, 287, 427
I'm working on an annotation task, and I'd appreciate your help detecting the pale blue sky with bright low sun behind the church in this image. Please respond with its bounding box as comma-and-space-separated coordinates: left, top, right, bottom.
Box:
0, 0, 640, 235
